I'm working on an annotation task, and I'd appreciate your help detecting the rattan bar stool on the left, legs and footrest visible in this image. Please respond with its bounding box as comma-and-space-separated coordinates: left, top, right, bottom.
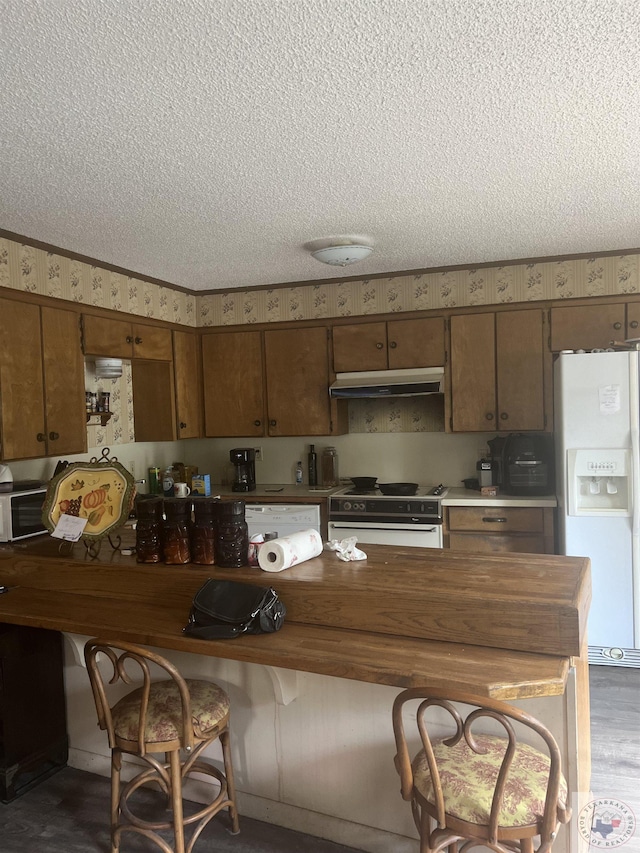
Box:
84, 639, 239, 853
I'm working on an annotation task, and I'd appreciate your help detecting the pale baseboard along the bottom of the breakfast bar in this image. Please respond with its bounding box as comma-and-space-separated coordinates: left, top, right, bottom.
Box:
68, 748, 418, 853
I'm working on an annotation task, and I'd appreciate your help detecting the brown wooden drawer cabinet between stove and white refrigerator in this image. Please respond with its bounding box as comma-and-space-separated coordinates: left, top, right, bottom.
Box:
446, 506, 555, 554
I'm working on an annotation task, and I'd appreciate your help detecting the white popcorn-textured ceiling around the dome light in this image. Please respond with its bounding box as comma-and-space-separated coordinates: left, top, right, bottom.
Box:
0, 0, 640, 291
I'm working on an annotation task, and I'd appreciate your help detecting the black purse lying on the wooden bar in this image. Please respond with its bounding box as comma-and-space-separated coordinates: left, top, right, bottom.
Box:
182, 578, 287, 640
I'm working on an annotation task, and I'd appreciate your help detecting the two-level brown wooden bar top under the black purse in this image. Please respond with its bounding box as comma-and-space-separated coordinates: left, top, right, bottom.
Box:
0, 537, 591, 700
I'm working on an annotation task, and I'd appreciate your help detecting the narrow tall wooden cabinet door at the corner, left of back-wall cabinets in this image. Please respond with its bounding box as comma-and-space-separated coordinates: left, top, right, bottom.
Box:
173, 332, 202, 438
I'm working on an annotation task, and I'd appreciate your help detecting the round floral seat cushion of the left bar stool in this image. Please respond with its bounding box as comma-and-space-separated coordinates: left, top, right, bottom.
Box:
111, 679, 229, 743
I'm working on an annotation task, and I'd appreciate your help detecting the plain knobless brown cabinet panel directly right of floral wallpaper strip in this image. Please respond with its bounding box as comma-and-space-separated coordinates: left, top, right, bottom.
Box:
131, 358, 176, 441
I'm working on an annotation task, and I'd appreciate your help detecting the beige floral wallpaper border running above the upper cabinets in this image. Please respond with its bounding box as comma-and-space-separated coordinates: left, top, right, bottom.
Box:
0, 237, 640, 328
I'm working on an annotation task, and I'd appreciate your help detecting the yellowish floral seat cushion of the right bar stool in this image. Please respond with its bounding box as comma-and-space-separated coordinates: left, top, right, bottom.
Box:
414, 735, 567, 827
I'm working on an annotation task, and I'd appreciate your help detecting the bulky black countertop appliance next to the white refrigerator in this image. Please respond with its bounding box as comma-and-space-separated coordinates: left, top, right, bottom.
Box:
502, 433, 554, 496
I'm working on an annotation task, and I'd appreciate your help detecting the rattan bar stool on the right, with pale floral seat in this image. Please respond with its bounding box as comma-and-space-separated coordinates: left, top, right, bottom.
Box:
393, 688, 571, 853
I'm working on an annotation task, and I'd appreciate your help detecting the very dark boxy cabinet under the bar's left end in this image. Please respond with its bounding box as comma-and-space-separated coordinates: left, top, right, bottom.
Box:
0, 624, 68, 803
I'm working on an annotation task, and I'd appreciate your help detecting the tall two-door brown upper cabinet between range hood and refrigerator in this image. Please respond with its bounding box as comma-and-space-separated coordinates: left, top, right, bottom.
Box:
451, 309, 545, 432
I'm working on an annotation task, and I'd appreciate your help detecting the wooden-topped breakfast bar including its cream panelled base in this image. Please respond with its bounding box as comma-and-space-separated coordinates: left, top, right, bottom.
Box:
0, 537, 591, 853
